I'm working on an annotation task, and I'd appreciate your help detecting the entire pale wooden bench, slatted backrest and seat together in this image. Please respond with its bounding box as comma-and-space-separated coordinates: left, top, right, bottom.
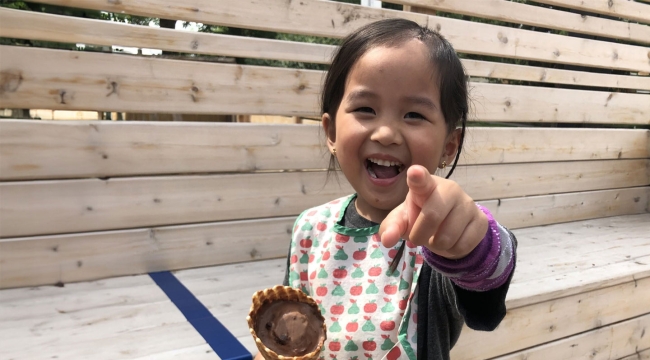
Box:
0, 0, 650, 360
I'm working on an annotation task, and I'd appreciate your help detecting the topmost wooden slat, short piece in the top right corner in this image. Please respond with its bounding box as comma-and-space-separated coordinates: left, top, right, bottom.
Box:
537, 0, 650, 24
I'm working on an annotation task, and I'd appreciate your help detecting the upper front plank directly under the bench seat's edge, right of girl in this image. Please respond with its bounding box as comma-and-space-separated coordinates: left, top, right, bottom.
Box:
451, 278, 650, 360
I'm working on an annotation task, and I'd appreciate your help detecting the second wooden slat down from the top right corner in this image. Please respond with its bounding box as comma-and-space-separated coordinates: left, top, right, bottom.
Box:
389, 0, 650, 44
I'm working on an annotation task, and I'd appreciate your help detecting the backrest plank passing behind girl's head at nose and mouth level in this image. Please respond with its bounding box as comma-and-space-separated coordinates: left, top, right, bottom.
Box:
0, 120, 650, 180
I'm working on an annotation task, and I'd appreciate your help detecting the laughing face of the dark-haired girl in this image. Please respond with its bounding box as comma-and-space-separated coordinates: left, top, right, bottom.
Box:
322, 39, 459, 222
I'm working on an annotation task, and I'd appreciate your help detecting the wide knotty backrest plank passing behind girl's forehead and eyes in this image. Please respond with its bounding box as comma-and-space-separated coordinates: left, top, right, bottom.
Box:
0, 46, 650, 124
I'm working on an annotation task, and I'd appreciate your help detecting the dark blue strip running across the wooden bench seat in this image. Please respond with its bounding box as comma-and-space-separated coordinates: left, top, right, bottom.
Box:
149, 271, 253, 360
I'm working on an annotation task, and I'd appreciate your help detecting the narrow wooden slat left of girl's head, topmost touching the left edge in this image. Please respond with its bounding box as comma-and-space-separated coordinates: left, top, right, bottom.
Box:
0, 8, 335, 64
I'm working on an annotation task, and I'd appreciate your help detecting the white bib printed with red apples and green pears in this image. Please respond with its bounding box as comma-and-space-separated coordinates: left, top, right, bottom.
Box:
289, 195, 422, 360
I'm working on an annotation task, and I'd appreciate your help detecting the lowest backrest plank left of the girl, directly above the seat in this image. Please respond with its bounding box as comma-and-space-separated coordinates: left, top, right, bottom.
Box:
0, 216, 295, 288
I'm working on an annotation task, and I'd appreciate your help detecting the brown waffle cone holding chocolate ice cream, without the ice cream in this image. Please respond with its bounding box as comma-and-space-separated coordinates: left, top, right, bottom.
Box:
246, 285, 327, 360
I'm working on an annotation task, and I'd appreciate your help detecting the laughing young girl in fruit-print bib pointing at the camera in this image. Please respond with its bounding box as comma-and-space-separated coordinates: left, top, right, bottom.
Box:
256, 19, 516, 360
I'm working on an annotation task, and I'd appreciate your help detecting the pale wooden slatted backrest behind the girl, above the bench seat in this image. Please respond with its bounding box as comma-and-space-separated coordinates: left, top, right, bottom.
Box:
0, 0, 650, 288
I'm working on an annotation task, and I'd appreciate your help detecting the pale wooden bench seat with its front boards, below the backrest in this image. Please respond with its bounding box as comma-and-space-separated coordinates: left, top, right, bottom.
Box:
0, 213, 650, 360
